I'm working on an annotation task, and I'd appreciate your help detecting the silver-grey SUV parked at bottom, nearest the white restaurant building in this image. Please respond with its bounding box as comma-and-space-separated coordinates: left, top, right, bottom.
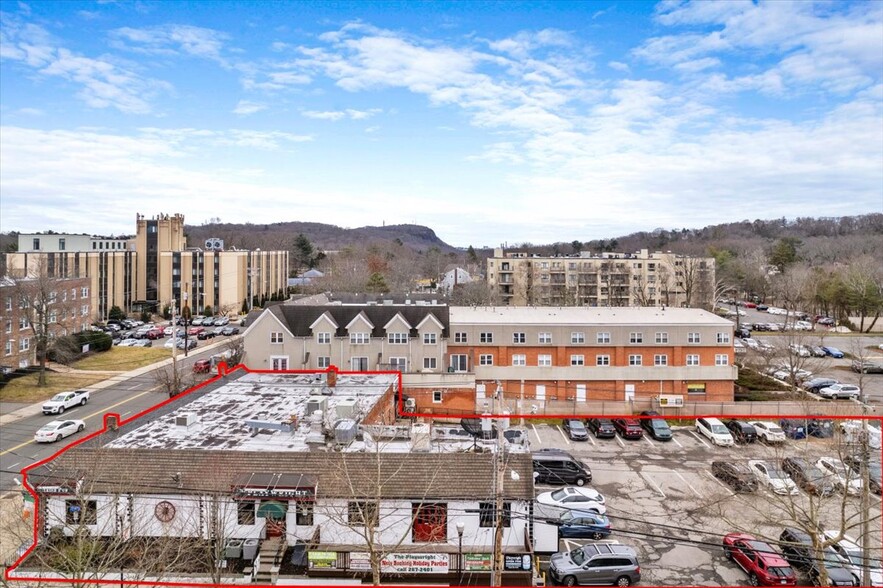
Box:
549, 543, 641, 586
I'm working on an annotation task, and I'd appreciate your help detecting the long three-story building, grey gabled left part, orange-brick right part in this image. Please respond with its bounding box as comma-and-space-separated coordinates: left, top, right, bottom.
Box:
243, 304, 738, 413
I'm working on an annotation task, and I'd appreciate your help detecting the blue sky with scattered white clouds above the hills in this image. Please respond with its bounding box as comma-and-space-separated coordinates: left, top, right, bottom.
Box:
0, 0, 883, 247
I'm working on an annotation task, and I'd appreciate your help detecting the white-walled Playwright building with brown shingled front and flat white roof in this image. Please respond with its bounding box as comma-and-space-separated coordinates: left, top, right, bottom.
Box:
15, 368, 534, 585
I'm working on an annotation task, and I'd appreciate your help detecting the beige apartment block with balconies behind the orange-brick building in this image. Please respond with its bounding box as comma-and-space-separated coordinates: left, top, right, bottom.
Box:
487, 248, 715, 308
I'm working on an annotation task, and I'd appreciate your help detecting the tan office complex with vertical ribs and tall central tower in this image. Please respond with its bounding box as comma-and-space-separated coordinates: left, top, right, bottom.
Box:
7, 214, 288, 320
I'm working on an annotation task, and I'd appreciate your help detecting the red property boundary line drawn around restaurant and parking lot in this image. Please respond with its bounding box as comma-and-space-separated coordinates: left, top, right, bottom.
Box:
3, 362, 883, 588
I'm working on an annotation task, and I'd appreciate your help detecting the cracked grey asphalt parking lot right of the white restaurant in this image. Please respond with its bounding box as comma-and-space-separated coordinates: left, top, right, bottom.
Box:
527, 425, 883, 585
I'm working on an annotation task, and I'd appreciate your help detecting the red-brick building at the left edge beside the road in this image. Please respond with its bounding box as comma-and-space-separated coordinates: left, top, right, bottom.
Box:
0, 278, 92, 369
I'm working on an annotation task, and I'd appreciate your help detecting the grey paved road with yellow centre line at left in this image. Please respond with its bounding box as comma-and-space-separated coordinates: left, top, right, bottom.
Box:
0, 338, 235, 494
